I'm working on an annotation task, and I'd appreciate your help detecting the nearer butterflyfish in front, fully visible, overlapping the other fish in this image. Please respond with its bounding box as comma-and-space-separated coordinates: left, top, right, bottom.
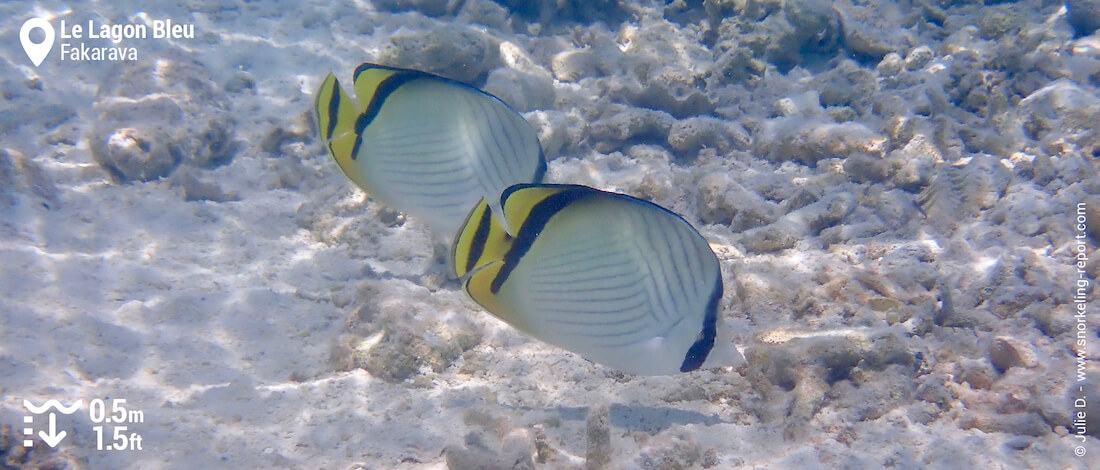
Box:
451, 184, 744, 375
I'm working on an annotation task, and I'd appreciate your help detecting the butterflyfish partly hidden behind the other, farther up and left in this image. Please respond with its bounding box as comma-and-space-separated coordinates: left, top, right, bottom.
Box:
315, 64, 546, 236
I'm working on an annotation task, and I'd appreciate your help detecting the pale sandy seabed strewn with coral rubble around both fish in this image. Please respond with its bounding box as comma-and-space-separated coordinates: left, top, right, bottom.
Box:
0, 0, 1100, 469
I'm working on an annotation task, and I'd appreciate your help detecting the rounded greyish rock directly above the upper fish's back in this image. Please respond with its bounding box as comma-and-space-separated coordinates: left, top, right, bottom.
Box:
378, 24, 501, 84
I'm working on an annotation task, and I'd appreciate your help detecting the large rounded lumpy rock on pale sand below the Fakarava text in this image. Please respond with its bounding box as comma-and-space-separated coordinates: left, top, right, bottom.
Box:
89, 58, 237, 183
